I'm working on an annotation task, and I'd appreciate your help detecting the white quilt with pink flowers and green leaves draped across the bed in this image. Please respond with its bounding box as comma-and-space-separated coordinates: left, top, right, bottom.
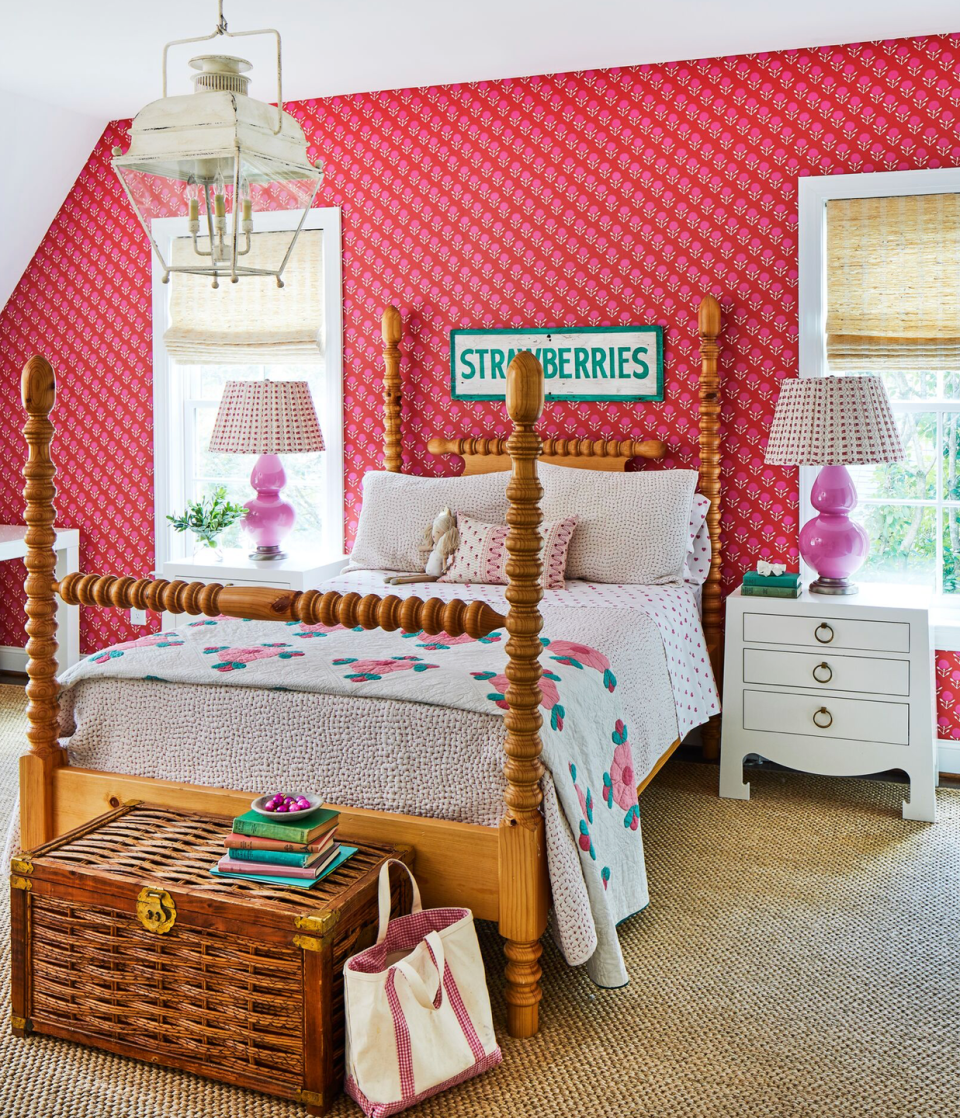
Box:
61, 617, 647, 986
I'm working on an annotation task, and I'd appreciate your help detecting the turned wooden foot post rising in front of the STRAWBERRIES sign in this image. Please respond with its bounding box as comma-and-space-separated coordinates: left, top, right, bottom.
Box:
498, 352, 548, 1036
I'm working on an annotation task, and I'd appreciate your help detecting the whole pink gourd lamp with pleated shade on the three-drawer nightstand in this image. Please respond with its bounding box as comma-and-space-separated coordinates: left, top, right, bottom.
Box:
766, 376, 904, 594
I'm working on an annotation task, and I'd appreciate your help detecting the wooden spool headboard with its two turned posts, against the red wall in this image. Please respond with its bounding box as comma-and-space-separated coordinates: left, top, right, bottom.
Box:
383, 295, 723, 759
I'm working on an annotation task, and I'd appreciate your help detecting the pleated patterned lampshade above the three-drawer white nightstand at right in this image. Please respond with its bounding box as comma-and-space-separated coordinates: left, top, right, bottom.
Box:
766, 377, 904, 466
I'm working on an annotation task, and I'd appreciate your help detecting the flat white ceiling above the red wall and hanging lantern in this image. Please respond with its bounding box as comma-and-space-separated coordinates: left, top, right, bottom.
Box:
0, 0, 960, 121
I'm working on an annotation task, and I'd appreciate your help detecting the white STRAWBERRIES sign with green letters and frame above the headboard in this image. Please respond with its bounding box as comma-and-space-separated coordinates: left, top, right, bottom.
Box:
450, 326, 664, 400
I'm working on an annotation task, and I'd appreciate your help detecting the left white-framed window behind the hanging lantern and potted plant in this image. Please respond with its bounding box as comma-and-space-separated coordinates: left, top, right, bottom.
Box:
153, 209, 343, 570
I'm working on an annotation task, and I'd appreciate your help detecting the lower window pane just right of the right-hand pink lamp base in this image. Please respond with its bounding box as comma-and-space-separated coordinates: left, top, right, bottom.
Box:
854, 504, 937, 589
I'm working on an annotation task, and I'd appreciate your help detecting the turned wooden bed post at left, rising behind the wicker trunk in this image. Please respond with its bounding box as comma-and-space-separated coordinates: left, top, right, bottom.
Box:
20, 357, 63, 850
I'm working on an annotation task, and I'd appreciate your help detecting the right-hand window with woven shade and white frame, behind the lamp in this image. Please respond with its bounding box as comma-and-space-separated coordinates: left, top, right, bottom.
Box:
800, 170, 960, 606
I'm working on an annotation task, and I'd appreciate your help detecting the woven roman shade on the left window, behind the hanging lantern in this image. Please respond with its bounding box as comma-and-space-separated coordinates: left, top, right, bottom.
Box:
163, 229, 323, 364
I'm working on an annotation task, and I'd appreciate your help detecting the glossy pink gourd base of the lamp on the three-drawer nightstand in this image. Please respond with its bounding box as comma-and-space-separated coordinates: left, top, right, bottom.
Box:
800, 466, 869, 594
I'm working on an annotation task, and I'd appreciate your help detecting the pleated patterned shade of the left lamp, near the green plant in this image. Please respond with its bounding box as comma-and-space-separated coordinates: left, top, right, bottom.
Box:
210, 380, 324, 454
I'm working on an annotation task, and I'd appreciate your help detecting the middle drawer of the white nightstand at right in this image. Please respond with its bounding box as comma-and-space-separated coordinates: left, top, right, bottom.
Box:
743, 648, 910, 697
